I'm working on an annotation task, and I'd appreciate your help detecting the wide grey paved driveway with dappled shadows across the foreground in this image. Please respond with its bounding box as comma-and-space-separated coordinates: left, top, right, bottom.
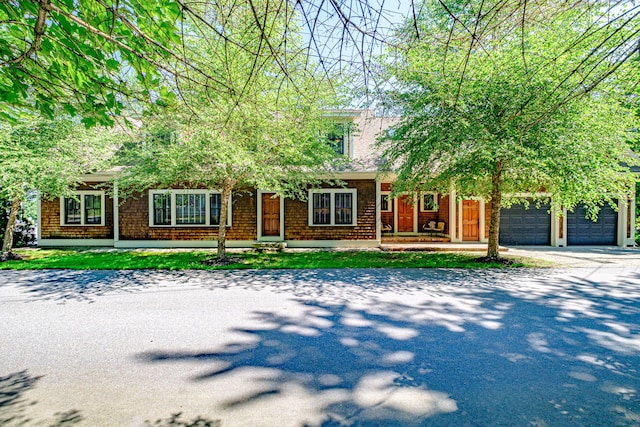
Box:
0, 266, 640, 426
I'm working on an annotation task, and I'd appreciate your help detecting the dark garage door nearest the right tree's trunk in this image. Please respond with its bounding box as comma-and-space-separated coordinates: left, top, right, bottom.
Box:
499, 202, 551, 245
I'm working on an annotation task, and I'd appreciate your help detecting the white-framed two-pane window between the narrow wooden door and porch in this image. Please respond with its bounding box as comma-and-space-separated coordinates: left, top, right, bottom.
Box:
309, 188, 358, 226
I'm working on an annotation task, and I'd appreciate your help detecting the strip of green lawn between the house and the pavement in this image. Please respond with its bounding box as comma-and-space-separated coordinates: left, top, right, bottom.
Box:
0, 248, 543, 270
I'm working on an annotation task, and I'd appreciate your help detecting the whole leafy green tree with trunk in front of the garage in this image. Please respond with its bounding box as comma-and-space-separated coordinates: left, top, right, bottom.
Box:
382, 1, 638, 258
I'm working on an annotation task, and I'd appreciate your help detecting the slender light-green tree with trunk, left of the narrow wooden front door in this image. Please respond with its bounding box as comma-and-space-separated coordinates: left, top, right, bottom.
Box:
118, 2, 342, 260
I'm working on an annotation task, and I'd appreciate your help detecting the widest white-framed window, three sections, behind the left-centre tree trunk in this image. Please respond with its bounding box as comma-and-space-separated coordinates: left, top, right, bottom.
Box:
149, 190, 232, 227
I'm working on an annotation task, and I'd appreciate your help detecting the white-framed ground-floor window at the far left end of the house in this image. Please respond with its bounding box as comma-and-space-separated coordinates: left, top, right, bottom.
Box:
60, 190, 105, 226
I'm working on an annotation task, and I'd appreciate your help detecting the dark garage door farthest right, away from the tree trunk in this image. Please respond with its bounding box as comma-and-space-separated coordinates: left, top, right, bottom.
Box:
567, 205, 618, 245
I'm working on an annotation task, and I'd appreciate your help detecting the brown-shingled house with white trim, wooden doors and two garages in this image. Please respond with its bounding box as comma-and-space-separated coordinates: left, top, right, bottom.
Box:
38, 110, 635, 248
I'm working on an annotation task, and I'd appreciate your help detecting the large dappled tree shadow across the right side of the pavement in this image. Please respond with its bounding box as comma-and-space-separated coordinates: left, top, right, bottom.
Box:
137, 270, 640, 426
